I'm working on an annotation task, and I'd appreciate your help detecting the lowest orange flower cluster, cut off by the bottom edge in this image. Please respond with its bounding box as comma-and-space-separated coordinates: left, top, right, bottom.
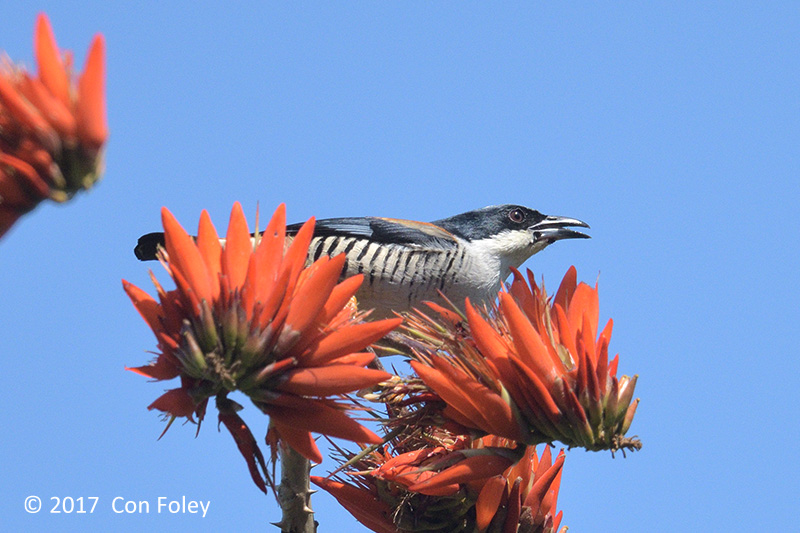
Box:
311, 437, 564, 533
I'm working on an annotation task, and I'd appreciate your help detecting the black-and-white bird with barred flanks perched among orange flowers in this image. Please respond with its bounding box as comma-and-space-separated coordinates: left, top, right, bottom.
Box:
134, 205, 589, 317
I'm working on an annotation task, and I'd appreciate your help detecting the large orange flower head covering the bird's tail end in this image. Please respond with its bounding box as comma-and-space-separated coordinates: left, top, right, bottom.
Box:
123, 203, 401, 490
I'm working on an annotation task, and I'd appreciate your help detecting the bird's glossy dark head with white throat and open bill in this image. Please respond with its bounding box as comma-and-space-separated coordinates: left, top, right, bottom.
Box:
434, 204, 589, 267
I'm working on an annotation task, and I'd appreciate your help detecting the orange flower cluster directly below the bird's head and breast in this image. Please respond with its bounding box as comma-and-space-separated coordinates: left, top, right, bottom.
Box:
404, 267, 641, 451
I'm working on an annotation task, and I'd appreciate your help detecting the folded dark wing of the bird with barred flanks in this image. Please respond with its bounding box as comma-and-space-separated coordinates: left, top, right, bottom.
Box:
286, 217, 458, 248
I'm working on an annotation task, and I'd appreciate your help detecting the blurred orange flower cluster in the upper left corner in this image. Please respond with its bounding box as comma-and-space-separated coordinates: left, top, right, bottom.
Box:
0, 14, 108, 237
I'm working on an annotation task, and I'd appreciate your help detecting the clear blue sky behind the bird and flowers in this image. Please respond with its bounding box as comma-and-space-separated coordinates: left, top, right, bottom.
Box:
0, 2, 800, 532
